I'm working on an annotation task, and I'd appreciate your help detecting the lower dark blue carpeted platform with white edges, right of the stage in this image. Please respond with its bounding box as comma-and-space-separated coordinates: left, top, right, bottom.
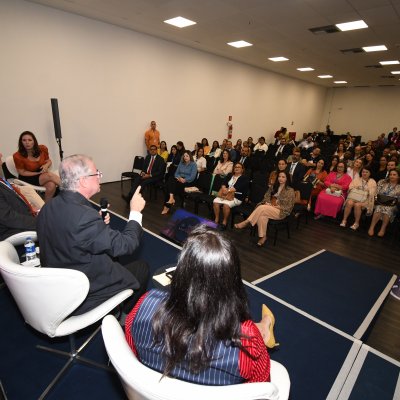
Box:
254, 251, 395, 339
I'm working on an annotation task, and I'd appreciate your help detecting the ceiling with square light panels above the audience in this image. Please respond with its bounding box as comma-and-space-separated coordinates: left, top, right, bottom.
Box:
31, 0, 400, 87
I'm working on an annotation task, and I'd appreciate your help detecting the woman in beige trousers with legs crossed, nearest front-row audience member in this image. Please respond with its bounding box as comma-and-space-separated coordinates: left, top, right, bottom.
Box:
235, 171, 294, 247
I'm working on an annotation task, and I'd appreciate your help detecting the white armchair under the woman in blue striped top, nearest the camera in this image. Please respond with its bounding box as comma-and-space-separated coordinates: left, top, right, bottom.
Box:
101, 315, 290, 400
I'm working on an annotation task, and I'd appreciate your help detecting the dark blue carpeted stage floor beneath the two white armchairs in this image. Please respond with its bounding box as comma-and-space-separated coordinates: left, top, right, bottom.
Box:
0, 211, 394, 400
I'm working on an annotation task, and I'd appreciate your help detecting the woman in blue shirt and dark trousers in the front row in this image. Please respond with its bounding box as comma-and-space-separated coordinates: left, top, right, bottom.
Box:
161, 150, 197, 214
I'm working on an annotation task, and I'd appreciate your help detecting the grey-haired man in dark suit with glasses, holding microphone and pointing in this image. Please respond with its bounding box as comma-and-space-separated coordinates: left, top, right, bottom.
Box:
37, 155, 148, 315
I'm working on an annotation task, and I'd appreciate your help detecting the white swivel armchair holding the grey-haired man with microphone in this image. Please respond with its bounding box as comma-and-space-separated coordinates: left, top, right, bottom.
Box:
0, 239, 133, 399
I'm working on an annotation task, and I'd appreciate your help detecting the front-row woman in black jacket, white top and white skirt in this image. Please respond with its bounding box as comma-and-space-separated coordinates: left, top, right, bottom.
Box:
213, 163, 249, 230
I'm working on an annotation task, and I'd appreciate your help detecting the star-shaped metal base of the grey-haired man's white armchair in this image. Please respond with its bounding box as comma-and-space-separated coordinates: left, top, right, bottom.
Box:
36, 325, 115, 400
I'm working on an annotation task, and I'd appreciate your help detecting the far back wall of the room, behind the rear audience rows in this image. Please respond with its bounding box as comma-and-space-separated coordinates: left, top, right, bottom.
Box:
321, 86, 400, 141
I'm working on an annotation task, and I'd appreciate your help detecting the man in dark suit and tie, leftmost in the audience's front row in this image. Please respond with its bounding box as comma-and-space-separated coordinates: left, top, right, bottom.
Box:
126, 145, 165, 201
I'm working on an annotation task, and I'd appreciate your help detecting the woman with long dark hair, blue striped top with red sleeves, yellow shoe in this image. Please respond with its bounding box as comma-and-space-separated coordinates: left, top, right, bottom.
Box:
125, 226, 275, 384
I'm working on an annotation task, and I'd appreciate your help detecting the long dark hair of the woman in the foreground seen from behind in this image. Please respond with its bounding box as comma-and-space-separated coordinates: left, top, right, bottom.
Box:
153, 226, 250, 375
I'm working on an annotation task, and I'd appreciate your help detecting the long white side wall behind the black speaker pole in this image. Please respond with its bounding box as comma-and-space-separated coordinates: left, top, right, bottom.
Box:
0, 0, 334, 182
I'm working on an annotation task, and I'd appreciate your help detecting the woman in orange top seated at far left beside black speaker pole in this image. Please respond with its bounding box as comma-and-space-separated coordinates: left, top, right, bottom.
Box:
13, 131, 60, 202
